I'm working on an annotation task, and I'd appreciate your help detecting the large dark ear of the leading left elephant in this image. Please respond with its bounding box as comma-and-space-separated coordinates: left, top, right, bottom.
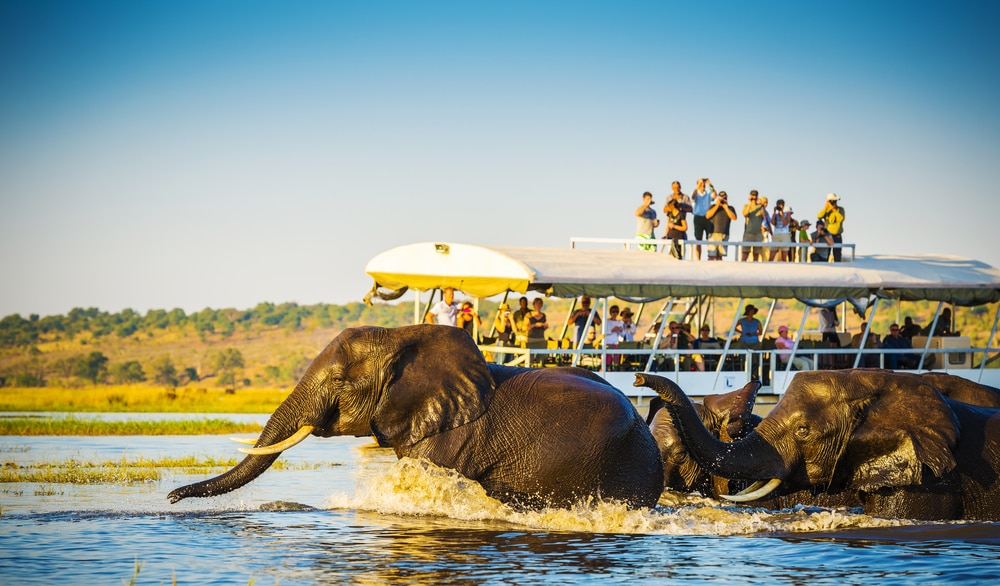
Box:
372, 324, 494, 447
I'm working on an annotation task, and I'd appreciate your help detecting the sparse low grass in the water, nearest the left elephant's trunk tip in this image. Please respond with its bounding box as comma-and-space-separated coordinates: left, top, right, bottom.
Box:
0, 456, 339, 484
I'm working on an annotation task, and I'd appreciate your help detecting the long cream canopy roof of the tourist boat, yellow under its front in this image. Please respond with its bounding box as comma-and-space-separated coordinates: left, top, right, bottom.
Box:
365, 242, 1000, 305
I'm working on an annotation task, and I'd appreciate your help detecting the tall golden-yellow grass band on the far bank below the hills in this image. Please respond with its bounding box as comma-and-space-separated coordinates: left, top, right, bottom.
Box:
0, 385, 289, 413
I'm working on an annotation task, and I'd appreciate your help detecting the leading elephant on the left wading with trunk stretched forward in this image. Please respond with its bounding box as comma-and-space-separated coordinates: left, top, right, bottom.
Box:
168, 324, 663, 508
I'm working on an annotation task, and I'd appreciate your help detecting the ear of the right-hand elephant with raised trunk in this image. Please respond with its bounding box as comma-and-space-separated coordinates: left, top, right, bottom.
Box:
843, 371, 959, 491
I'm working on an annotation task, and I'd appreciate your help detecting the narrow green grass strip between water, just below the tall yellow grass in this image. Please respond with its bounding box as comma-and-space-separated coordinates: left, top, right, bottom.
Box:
0, 416, 261, 436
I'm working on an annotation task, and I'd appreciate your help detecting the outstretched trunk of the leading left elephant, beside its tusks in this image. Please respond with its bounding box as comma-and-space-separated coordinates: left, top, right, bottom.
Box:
167, 389, 314, 503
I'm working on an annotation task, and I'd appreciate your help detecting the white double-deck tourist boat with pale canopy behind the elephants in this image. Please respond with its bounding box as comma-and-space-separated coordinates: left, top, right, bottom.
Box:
365, 238, 1000, 404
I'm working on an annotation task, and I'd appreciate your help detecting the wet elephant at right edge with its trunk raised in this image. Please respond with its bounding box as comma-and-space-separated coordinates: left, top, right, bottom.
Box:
636, 369, 1000, 521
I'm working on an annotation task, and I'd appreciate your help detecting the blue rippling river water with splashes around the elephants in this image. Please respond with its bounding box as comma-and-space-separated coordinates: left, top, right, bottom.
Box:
0, 416, 1000, 586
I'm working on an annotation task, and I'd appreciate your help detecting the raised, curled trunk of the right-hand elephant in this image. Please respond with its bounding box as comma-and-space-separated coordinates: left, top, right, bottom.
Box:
635, 374, 785, 480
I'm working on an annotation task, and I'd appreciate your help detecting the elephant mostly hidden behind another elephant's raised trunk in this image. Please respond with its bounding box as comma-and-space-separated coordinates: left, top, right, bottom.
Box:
640, 375, 761, 498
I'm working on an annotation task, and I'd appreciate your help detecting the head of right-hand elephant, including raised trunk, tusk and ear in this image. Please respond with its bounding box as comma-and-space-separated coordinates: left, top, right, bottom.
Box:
644, 369, 959, 501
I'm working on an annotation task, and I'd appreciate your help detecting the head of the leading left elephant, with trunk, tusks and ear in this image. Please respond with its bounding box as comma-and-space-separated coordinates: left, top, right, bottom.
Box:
168, 325, 494, 502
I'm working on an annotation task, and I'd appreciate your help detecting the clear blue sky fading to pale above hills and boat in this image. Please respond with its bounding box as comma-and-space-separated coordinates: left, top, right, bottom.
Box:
0, 0, 1000, 316
